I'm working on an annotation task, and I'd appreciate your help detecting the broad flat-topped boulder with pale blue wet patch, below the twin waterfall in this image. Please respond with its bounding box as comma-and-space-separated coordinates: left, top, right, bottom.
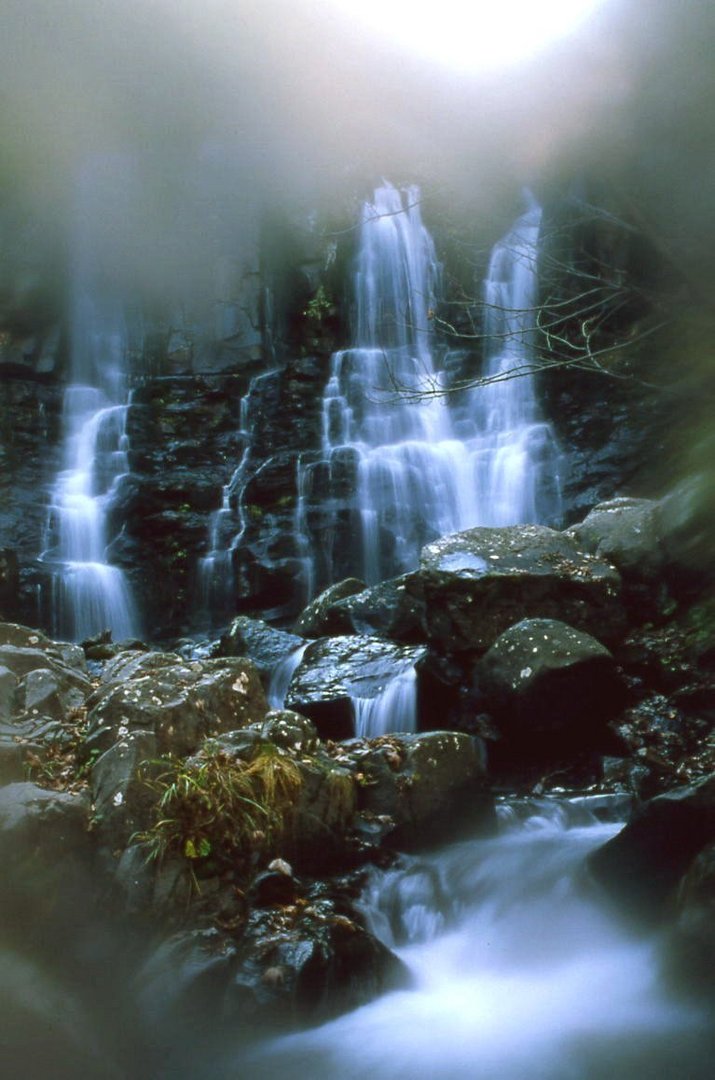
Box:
408, 525, 625, 652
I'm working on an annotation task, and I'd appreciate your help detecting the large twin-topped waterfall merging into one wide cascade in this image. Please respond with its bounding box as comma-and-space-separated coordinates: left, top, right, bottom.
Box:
298, 184, 558, 588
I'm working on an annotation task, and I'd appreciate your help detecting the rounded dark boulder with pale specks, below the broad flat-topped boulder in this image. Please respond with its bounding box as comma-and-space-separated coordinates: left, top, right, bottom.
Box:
476, 619, 624, 757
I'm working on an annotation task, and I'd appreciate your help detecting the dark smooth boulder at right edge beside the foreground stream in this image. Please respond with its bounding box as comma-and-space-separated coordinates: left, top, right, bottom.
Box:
589, 774, 715, 920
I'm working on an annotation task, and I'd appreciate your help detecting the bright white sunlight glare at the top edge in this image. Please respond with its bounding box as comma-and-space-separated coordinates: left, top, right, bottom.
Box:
330, 0, 604, 73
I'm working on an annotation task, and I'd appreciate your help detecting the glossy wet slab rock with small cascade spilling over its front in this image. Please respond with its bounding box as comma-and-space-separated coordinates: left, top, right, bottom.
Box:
285, 636, 426, 739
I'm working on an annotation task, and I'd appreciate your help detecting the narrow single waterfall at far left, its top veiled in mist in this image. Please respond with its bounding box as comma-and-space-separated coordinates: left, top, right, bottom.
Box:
40, 159, 137, 640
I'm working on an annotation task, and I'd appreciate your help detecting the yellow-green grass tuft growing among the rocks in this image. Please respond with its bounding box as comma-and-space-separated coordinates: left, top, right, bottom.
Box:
138, 743, 302, 868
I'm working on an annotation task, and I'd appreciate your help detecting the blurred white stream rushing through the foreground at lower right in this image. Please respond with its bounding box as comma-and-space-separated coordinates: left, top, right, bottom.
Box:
245, 800, 711, 1080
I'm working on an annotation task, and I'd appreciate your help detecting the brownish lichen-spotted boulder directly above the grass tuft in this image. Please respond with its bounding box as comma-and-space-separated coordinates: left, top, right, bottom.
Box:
86, 652, 268, 756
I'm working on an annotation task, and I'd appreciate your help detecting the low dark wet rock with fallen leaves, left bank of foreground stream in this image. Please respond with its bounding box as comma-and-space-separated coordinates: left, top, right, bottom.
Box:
137, 888, 408, 1034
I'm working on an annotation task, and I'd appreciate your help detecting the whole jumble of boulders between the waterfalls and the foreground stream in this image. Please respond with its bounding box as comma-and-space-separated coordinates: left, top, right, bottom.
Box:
0, 500, 715, 1058
